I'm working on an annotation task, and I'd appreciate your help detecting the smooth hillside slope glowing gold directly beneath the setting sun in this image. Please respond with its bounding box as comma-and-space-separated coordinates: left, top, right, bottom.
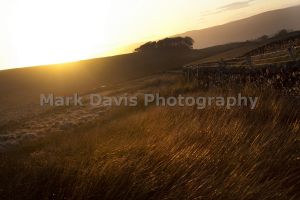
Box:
0, 51, 204, 116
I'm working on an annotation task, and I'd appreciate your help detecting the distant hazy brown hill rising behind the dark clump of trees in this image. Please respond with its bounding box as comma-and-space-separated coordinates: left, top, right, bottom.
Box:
177, 6, 300, 49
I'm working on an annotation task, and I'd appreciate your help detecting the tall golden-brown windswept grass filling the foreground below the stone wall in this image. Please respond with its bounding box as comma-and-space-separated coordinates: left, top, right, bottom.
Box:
0, 74, 300, 200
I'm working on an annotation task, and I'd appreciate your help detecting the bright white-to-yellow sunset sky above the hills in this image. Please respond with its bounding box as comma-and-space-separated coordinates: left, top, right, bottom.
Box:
0, 0, 300, 69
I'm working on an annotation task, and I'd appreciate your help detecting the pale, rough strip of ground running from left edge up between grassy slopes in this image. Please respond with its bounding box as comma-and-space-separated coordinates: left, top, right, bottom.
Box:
0, 73, 181, 151
